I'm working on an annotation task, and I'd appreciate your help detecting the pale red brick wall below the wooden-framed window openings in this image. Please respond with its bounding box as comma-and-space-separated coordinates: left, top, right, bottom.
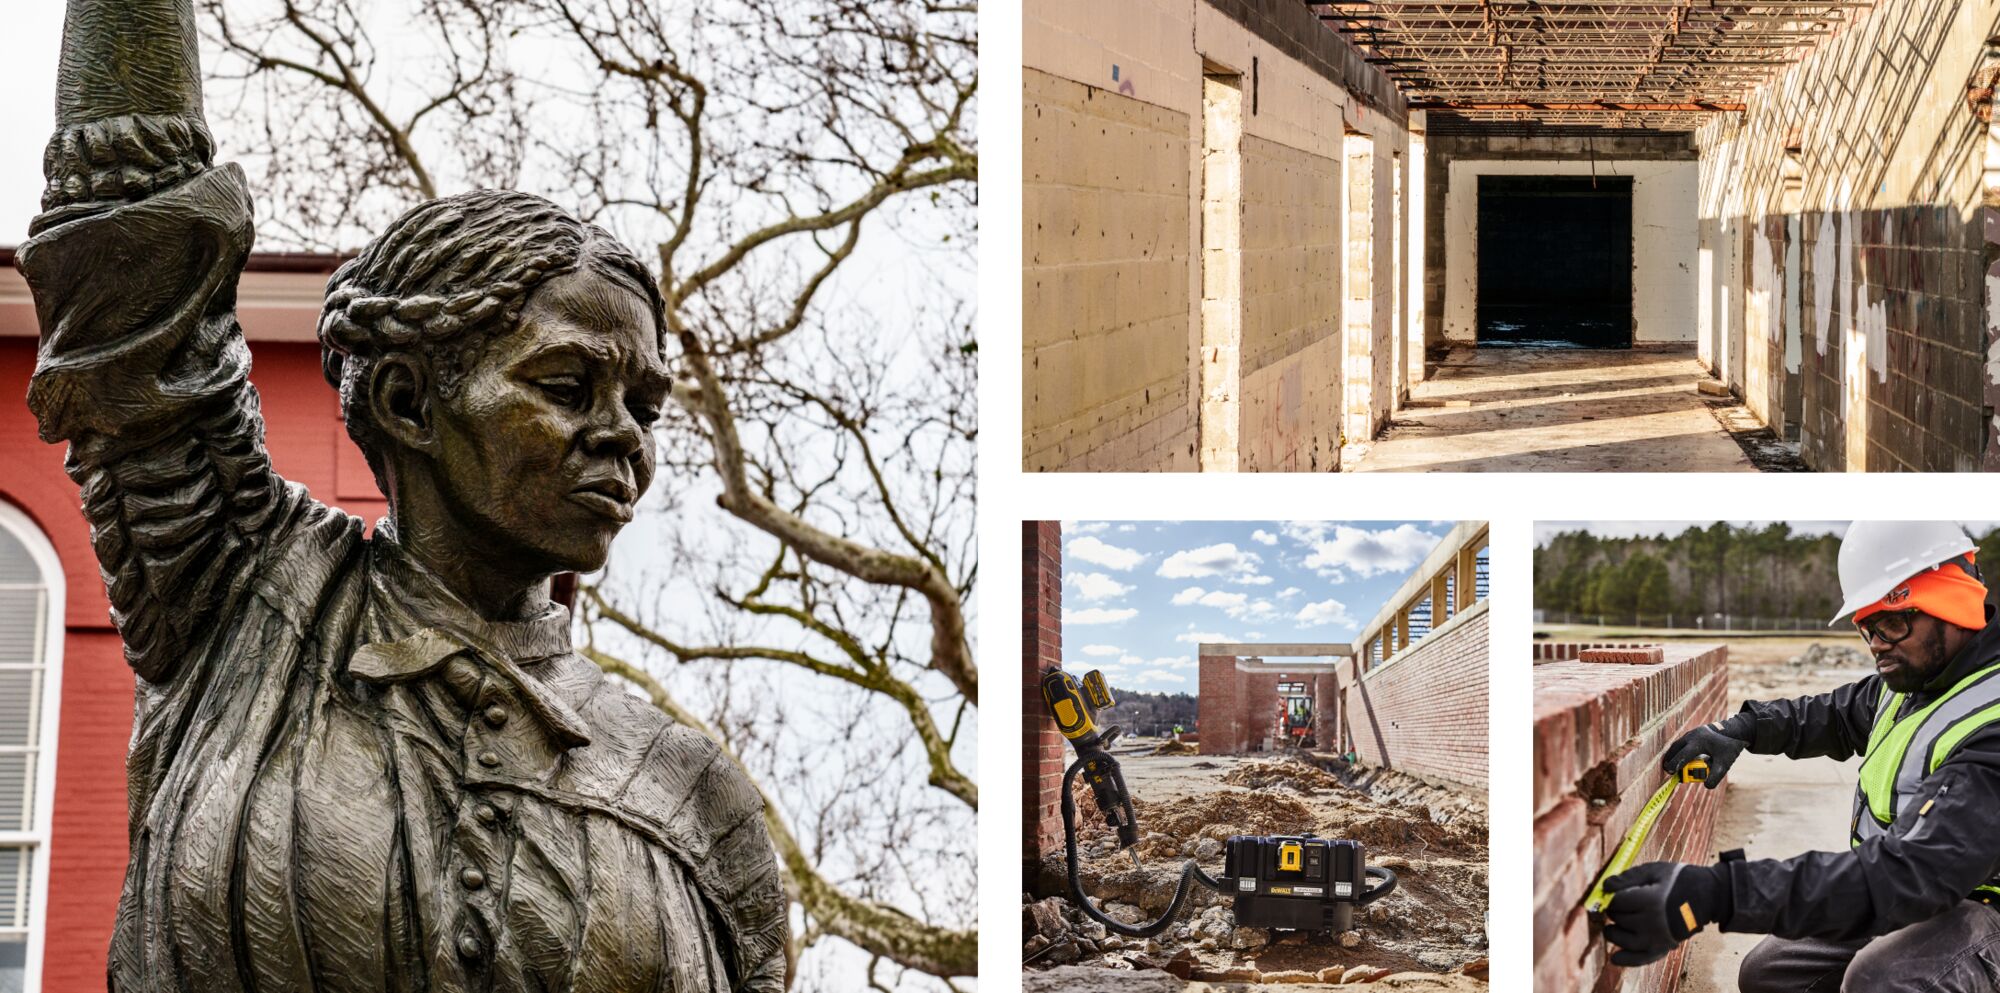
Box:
1340, 603, 1488, 787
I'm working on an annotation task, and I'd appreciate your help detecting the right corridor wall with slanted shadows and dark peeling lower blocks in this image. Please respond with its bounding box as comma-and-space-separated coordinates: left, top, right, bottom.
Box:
1696, 0, 2000, 470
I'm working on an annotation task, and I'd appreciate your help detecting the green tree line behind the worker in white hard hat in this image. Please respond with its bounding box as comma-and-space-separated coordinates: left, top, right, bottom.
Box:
1534, 521, 2000, 623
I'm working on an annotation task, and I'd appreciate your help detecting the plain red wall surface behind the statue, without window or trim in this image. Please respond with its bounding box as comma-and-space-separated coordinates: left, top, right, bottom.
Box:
0, 334, 388, 993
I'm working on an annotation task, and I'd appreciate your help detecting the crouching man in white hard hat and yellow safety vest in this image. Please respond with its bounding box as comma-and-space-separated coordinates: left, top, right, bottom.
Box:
1604, 521, 2000, 993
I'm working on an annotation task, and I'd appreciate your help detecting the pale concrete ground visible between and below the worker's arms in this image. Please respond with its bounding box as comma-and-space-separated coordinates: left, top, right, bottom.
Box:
1680, 755, 1862, 993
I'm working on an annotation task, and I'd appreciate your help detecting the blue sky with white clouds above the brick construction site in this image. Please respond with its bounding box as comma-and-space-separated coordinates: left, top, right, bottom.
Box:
1062, 521, 1452, 693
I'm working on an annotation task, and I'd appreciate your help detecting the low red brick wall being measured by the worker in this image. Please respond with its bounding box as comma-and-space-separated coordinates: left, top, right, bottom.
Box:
1534, 645, 1728, 993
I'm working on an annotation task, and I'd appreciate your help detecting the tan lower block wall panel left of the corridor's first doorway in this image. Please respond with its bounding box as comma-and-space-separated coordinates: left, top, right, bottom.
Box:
1022, 68, 1194, 468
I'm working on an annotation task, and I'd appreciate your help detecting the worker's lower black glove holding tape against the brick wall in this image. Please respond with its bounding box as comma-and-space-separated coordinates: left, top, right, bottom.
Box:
1604, 863, 1736, 965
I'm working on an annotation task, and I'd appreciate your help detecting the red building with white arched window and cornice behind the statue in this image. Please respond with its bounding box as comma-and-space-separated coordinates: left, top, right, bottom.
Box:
0, 250, 386, 993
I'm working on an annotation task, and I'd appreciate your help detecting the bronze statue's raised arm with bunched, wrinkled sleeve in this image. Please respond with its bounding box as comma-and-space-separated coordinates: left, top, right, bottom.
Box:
20, 0, 282, 681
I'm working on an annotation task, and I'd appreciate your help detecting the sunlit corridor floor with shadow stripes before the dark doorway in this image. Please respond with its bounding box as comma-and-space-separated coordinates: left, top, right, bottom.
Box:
1342, 346, 1756, 472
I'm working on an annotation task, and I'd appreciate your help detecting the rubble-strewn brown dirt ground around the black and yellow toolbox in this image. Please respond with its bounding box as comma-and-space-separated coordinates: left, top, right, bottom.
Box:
1022, 739, 1486, 991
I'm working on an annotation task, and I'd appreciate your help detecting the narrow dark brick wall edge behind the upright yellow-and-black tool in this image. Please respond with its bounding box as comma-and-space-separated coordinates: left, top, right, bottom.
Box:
1020, 521, 1068, 879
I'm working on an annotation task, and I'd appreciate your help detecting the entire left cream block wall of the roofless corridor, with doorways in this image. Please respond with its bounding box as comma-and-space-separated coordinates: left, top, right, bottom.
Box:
1022, 0, 1414, 470
